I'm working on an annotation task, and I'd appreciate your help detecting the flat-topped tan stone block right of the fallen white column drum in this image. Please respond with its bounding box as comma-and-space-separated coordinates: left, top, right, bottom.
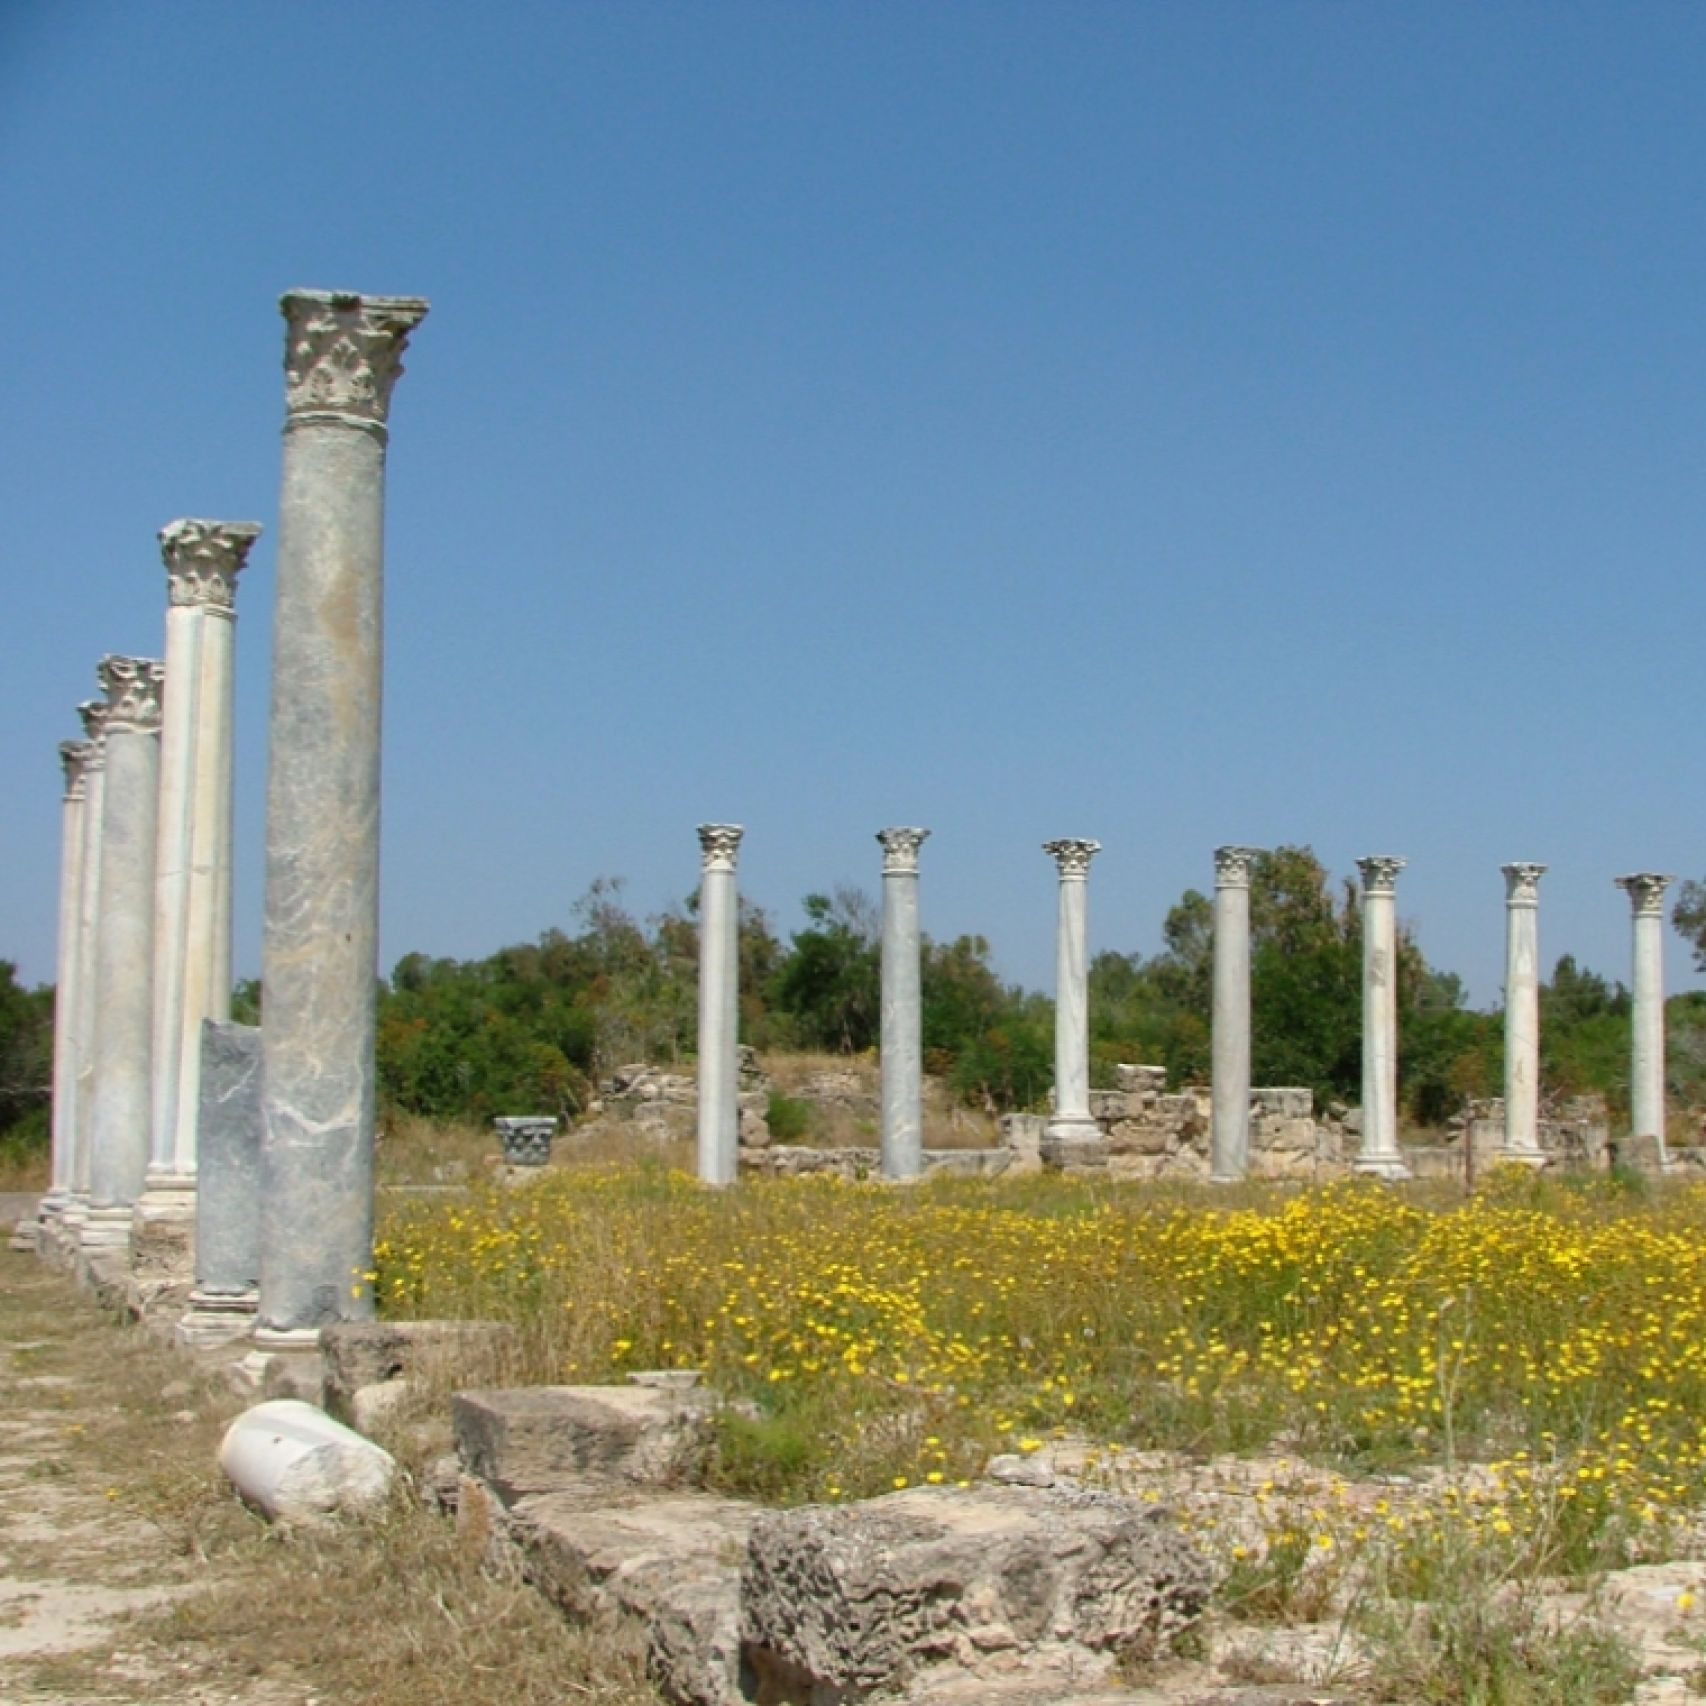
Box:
450, 1385, 710, 1503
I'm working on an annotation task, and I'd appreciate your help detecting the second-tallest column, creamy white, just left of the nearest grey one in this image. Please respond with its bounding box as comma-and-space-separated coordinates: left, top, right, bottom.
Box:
138, 520, 261, 1216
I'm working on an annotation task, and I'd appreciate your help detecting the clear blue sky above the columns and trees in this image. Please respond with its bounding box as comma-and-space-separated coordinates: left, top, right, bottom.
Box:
0, 0, 1706, 1001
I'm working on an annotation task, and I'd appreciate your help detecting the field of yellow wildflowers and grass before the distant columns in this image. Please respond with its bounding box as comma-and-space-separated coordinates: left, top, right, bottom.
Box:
370, 1167, 1706, 1588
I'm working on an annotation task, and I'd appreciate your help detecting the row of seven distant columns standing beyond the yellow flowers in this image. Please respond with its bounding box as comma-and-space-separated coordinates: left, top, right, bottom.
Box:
698, 824, 1672, 1184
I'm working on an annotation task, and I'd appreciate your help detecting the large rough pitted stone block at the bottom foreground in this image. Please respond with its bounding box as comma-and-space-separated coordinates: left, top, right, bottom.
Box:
740, 1486, 1211, 1706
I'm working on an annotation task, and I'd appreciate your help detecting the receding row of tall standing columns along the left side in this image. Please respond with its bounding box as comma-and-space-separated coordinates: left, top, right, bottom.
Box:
43, 290, 427, 1344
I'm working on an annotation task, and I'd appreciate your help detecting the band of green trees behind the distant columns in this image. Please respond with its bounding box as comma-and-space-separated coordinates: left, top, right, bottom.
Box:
10, 848, 1706, 1138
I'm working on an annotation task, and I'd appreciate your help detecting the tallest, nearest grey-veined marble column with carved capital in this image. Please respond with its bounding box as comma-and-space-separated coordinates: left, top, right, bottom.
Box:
256, 290, 427, 1349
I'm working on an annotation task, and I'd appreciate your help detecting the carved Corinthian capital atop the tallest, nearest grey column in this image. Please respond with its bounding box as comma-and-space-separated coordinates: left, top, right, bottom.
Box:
278, 290, 428, 430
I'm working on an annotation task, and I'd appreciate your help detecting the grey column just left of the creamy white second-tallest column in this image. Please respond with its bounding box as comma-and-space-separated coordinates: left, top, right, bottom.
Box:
82, 657, 165, 1245
